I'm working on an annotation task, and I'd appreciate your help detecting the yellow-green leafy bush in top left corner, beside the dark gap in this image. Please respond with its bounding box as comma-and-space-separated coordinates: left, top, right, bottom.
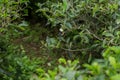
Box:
0, 0, 29, 37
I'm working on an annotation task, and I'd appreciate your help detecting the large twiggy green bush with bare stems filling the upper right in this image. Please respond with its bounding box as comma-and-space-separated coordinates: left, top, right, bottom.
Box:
36, 0, 120, 56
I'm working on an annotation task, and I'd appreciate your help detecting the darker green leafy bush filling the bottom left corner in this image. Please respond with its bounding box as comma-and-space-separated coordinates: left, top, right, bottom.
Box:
0, 37, 38, 80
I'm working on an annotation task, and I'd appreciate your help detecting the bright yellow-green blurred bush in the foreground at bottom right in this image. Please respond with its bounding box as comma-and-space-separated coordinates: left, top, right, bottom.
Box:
36, 46, 120, 80
